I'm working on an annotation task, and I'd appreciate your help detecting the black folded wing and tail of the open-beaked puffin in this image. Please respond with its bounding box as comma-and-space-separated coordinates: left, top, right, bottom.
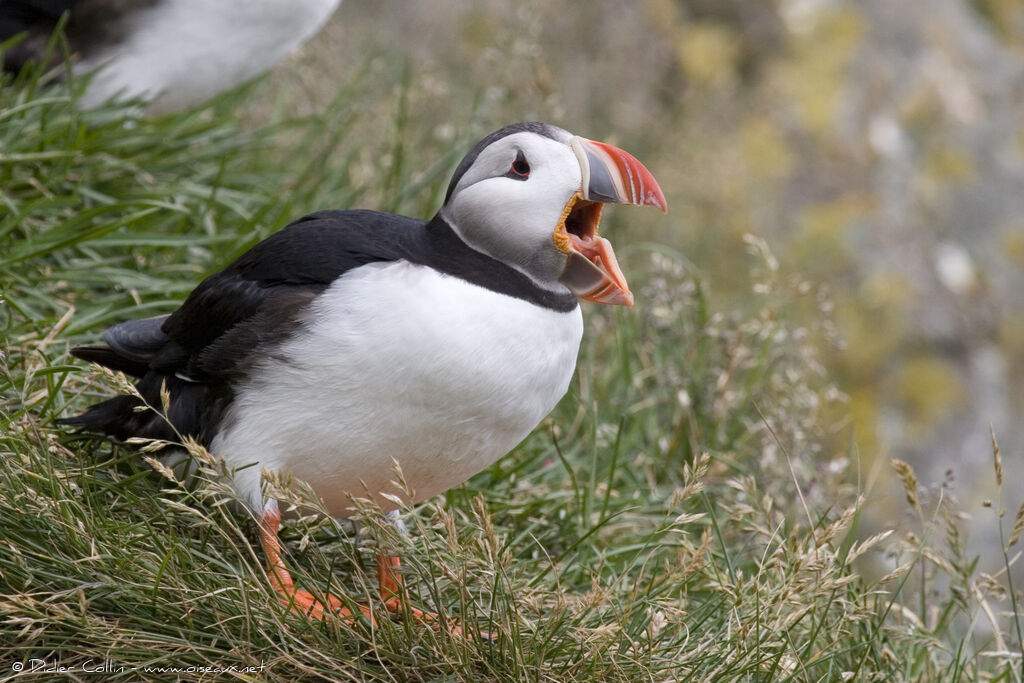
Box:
61, 211, 425, 445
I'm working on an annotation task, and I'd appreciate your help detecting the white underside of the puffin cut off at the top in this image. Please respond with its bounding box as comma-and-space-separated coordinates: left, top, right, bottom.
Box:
78, 0, 341, 112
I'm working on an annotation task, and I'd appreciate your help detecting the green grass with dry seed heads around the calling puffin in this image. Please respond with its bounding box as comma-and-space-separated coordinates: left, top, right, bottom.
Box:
0, 62, 1020, 681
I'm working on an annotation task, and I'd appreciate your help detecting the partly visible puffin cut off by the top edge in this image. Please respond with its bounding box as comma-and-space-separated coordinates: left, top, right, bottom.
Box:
0, 0, 341, 114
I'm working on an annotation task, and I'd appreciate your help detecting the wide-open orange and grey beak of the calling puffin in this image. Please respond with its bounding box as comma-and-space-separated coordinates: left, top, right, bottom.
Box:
554, 137, 669, 306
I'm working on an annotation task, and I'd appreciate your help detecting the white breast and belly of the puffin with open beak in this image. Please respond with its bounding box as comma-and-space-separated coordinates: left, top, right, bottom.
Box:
212, 261, 583, 516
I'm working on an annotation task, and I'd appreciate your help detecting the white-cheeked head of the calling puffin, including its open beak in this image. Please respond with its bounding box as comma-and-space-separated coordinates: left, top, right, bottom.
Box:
440, 123, 668, 306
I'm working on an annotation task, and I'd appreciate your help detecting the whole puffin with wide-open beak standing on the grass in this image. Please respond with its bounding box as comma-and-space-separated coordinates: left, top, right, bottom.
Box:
61, 122, 667, 630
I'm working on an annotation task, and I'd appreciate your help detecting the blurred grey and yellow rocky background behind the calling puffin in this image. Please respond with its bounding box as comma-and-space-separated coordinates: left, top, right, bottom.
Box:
258, 0, 1024, 544
